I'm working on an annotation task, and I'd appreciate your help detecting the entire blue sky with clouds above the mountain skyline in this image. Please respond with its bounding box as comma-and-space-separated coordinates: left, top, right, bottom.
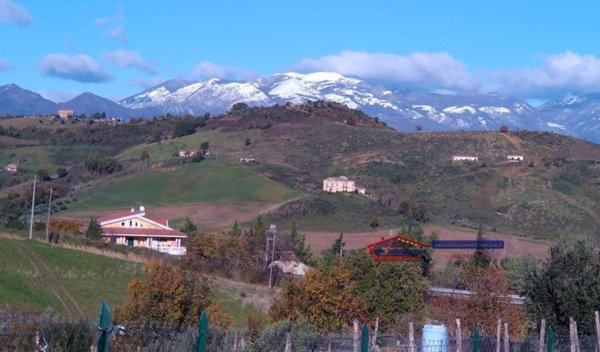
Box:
0, 0, 600, 101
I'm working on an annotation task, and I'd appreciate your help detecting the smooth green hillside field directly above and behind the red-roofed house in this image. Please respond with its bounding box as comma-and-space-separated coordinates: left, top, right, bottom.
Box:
71, 160, 299, 210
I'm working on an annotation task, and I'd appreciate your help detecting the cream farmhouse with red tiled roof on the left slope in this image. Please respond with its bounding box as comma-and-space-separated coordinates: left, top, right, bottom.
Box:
81, 207, 187, 255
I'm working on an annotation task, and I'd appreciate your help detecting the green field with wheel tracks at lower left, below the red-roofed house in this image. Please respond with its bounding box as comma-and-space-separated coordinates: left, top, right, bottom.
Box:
0, 238, 143, 316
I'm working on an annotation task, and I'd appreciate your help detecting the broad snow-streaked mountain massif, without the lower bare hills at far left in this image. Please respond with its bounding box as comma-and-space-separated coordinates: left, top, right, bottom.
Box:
120, 72, 553, 135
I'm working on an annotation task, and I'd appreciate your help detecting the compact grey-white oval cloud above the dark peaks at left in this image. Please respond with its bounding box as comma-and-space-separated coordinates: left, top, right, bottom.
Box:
39, 53, 113, 83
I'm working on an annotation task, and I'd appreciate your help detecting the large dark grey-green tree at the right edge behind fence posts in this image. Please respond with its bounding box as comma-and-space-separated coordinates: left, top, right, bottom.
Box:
524, 238, 600, 335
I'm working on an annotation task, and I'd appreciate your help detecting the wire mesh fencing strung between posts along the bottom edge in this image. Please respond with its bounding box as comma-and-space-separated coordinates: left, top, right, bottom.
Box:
0, 311, 597, 352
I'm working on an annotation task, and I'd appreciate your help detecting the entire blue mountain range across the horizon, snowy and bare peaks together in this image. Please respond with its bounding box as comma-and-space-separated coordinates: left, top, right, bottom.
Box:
0, 72, 600, 143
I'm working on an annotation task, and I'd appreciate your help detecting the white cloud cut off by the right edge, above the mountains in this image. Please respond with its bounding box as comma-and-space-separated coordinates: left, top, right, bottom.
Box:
492, 51, 600, 98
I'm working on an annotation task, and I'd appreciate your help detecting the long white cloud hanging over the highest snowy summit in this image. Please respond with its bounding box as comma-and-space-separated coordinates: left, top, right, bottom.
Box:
296, 51, 478, 90
